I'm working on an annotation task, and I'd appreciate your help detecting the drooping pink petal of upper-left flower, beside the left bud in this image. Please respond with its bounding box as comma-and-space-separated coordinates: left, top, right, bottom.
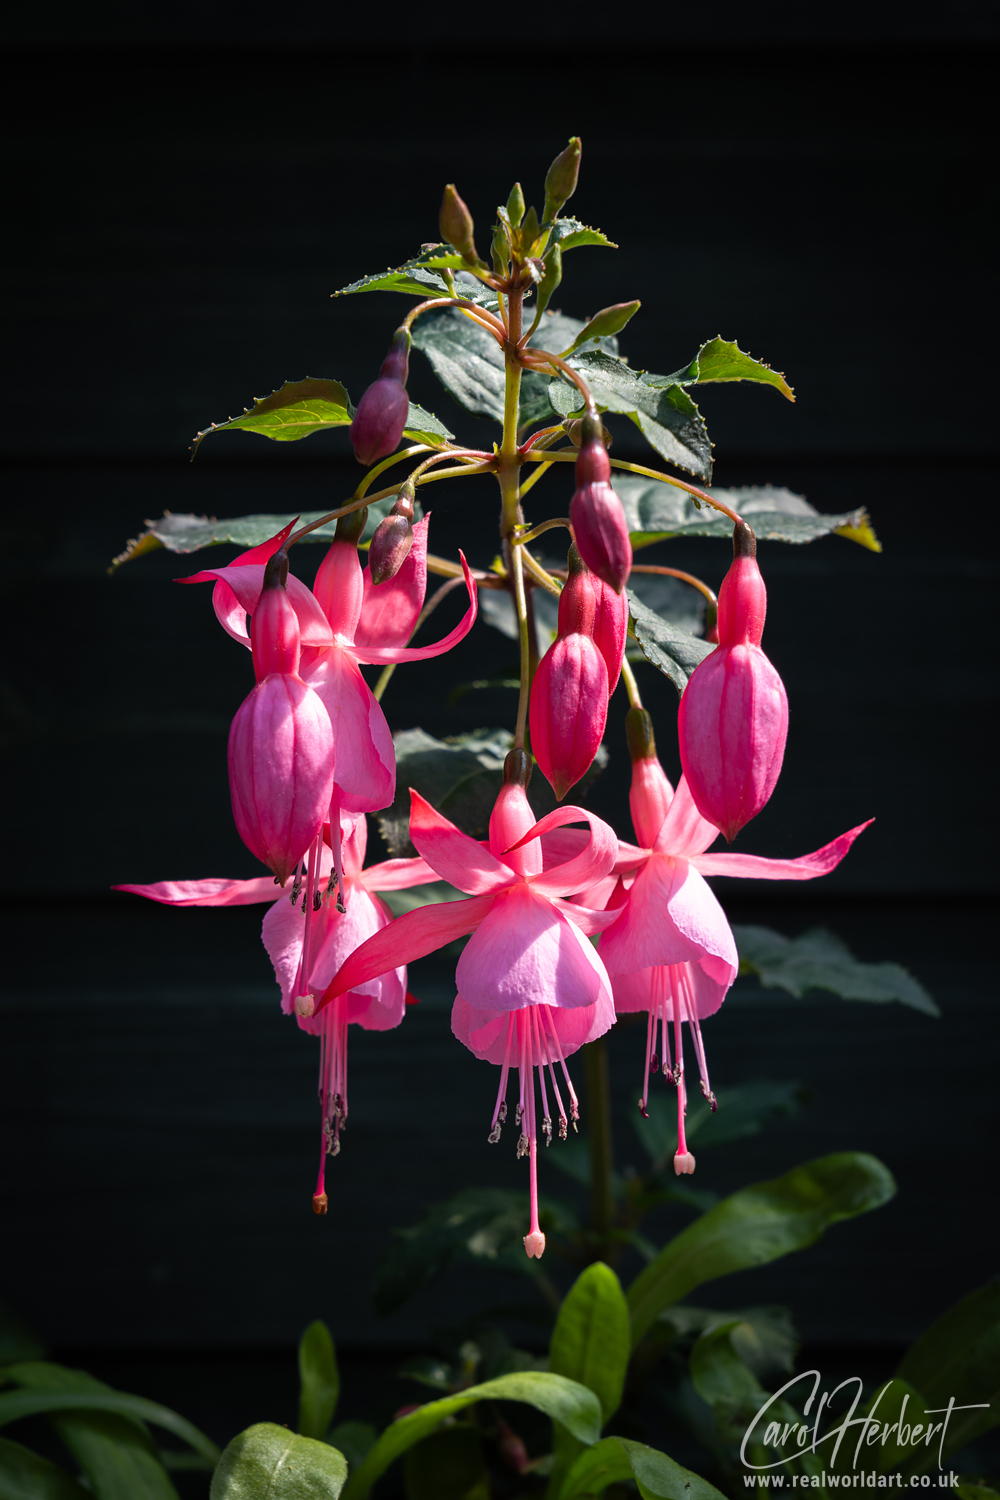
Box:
306, 647, 396, 813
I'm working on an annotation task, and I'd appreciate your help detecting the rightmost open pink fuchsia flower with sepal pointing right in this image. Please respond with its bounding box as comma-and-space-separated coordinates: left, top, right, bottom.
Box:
599, 708, 871, 1173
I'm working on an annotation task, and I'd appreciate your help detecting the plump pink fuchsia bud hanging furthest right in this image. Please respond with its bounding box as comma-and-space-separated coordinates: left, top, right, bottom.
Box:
678, 521, 789, 843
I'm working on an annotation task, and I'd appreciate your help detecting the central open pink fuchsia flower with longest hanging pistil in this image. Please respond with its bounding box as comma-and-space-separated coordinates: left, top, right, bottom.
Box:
321, 750, 618, 1256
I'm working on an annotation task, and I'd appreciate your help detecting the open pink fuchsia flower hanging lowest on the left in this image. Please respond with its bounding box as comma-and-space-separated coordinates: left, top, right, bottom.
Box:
115, 816, 438, 1214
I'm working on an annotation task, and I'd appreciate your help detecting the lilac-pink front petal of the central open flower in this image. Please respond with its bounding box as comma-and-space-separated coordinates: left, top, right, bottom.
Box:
456, 881, 609, 1011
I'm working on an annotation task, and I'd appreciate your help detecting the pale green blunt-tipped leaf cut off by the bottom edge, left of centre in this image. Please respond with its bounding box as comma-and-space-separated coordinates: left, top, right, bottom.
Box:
211, 1422, 348, 1500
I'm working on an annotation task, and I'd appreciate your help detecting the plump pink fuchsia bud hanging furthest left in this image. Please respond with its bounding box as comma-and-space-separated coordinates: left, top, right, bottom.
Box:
229, 551, 333, 885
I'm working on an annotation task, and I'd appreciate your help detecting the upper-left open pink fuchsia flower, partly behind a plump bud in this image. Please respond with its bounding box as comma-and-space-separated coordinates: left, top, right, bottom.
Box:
181, 512, 477, 821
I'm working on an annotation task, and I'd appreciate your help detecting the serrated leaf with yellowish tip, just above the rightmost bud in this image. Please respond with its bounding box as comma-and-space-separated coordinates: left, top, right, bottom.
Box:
615, 473, 882, 552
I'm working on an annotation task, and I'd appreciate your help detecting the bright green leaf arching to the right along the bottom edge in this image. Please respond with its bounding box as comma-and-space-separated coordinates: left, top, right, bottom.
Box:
344, 1370, 601, 1500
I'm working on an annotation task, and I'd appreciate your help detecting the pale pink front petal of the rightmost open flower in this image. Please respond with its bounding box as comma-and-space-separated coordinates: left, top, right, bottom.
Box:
601, 855, 739, 983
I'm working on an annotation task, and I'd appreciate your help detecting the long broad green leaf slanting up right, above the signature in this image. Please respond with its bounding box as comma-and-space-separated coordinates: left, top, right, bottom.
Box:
627, 1151, 895, 1344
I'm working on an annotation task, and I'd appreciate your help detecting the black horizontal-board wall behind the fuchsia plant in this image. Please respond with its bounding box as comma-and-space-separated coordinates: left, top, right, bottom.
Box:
0, 5, 997, 1464
